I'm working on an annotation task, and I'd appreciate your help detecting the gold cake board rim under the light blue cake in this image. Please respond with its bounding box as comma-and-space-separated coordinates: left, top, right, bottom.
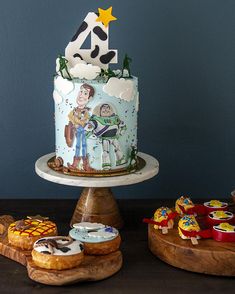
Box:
47, 156, 146, 178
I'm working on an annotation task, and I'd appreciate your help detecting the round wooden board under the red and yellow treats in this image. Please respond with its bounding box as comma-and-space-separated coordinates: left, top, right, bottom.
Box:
148, 224, 235, 276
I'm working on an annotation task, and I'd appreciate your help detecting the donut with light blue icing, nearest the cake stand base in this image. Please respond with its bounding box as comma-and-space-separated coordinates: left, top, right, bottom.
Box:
69, 222, 121, 255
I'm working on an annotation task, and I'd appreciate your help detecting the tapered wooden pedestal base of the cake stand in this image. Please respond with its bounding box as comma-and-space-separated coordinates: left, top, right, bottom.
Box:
70, 188, 123, 229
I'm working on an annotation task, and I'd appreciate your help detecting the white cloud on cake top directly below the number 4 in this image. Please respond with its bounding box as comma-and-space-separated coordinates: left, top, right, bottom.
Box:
70, 63, 101, 80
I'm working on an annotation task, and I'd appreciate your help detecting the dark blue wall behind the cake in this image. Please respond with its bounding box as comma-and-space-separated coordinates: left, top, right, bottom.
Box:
0, 0, 235, 198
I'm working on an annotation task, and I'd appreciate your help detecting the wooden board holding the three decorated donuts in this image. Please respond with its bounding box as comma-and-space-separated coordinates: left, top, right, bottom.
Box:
0, 216, 122, 286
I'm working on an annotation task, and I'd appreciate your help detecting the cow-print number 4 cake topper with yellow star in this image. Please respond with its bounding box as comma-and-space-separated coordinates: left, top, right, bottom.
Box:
65, 7, 117, 69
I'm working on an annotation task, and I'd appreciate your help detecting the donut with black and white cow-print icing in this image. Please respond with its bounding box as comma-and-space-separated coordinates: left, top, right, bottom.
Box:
32, 236, 84, 270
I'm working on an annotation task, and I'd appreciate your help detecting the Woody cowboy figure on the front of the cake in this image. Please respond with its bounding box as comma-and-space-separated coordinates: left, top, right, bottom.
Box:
65, 84, 95, 171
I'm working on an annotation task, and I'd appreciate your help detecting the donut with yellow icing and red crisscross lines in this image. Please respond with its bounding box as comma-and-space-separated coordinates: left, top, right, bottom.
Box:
8, 217, 57, 250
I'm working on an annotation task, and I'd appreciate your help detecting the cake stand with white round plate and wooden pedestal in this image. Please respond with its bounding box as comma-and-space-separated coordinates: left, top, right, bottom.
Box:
35, 152, 159, 229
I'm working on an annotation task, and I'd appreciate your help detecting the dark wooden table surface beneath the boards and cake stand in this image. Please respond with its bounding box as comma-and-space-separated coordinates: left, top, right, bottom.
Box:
0, 200, 235, 294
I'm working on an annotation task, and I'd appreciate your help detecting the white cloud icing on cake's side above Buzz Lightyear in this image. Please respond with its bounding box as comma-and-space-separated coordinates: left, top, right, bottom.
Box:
103, 77, 135, 101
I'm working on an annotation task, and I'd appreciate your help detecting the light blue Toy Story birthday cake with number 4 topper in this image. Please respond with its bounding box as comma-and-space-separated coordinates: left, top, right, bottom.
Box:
51, 7, 139, 175
